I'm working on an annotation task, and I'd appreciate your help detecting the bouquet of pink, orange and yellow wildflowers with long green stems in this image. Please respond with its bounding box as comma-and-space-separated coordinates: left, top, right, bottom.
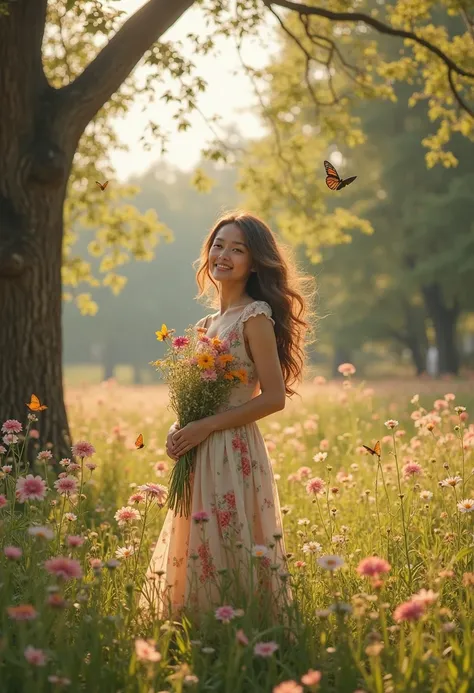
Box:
151, 325, 247, 517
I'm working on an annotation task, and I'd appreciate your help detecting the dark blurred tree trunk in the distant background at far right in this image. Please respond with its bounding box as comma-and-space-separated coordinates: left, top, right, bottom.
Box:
422, 282, 460, 375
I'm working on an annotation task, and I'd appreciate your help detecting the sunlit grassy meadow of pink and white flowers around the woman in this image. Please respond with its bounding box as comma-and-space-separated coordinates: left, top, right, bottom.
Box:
0, 374, 474, 693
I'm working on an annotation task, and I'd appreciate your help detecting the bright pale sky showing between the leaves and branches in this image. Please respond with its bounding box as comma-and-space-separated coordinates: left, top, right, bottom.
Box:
111, 0, 276, 181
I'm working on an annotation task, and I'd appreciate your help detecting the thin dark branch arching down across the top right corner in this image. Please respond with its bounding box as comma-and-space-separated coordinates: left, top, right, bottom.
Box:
263, 0, 474, 79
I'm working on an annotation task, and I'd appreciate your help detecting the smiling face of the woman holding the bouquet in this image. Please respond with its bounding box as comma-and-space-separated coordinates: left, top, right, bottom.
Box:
209, 224, 252, 283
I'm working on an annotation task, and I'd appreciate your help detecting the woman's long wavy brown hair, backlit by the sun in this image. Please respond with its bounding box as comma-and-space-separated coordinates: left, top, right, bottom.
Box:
194, 210, 314, 396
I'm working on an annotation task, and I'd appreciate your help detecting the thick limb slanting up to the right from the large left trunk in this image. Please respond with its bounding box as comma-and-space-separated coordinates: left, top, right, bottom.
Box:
61, 0, 194, 136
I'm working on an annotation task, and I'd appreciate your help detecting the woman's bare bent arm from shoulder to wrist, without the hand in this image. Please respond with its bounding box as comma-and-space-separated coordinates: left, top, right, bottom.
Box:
203, 314, 286, 432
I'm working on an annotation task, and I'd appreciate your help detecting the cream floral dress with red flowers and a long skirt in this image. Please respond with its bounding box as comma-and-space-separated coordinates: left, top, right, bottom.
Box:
140, 301, 291, 619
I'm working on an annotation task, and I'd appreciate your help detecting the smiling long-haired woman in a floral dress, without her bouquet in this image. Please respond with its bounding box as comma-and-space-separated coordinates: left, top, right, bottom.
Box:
141, 212, 309, 617
